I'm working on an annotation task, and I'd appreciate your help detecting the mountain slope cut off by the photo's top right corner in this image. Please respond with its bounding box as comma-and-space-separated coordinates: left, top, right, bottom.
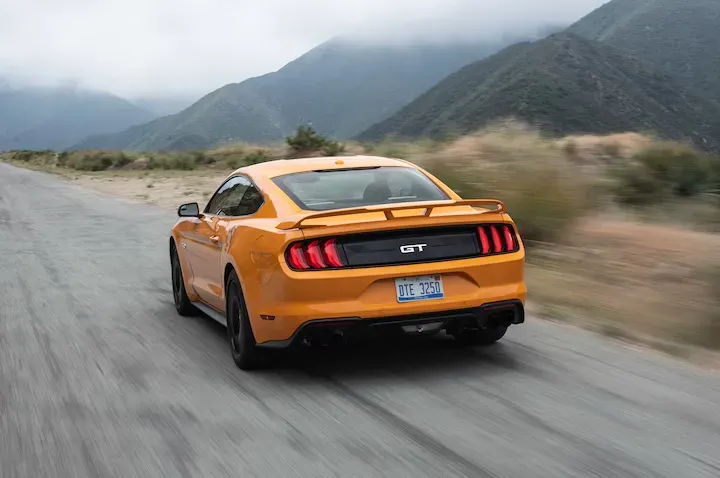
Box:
568, 0, 720, 103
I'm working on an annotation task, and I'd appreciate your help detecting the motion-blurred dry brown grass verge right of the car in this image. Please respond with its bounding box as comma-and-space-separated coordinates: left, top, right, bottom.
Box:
528, 216, 720, 347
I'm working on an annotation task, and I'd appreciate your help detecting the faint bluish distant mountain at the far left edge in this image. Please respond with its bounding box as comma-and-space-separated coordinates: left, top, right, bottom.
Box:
0, 85, 154, 151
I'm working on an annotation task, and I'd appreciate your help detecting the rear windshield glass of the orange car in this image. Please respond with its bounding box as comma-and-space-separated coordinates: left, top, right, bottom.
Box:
273, 166, 450, 211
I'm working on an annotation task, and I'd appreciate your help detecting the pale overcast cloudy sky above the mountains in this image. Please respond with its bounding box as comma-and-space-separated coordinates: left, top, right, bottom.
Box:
0, 0, 607, 97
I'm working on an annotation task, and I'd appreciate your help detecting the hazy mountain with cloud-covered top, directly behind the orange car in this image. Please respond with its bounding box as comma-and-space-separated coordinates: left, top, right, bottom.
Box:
74, 39, 524, 150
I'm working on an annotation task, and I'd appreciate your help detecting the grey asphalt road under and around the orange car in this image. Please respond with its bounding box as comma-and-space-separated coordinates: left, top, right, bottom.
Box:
0, 163, 720, 478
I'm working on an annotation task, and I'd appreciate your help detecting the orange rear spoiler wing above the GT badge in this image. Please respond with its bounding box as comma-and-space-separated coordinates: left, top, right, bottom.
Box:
277, 199, 506, 230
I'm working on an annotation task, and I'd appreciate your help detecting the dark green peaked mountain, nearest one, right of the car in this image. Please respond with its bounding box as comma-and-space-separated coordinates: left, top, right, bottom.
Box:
358, 32, 720, 149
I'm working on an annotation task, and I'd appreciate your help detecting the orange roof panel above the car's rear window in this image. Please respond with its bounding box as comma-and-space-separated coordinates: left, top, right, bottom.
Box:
238, 155, 412, 178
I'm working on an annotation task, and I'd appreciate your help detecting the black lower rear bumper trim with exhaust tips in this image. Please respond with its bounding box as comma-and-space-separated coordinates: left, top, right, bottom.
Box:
258, 299, 525, 349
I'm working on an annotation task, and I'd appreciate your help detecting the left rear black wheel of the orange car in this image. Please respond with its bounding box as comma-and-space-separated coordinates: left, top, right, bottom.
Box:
225, 271, 260, 370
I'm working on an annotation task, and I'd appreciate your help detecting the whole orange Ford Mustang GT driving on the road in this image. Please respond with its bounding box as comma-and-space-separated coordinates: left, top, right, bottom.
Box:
170, 156, 526, 369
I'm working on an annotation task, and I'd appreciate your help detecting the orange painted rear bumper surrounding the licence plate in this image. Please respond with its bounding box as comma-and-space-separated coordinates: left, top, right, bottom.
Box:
250, 250, 527, 344
